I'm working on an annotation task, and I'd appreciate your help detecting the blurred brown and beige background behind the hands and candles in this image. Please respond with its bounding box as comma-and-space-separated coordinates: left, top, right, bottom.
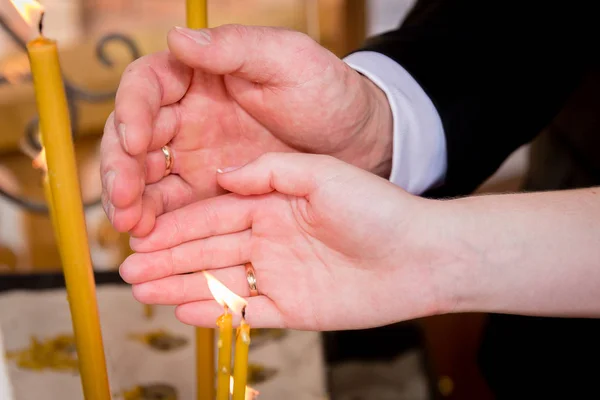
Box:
0, 0, 528, 400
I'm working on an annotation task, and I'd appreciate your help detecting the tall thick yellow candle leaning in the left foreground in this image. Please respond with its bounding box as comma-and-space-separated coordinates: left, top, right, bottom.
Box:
27, 15, 111, 400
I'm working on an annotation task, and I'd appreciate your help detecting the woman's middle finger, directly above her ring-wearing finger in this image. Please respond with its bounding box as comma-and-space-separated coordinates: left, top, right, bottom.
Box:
119, 229, 252, 284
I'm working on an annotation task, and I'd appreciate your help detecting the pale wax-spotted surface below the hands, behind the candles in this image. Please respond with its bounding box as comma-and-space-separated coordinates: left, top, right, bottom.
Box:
0, 285, 326, 400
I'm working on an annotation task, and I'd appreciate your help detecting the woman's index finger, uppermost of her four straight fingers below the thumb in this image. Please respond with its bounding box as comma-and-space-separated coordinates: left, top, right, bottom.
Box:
130, 191, 256, 252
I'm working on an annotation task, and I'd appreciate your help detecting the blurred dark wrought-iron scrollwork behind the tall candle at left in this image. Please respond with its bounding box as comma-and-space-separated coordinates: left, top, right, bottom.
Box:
0, 15, 141, 214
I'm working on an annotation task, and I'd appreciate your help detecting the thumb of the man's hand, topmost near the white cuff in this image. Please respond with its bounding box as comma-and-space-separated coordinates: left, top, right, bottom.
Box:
167, 25, 333, 85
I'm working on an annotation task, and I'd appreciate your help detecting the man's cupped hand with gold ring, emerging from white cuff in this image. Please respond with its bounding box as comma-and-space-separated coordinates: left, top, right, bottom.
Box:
101, 25, 392, 236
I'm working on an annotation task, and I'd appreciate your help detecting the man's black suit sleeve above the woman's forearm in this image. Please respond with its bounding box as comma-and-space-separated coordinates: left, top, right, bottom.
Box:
360, 0, 600, 197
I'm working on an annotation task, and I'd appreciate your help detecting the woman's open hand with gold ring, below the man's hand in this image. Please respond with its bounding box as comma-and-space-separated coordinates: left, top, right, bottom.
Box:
120, 153, 440, 330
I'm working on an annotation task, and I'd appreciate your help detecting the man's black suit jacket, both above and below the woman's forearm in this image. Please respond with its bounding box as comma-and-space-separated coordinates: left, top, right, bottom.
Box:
360, 0, 600, 399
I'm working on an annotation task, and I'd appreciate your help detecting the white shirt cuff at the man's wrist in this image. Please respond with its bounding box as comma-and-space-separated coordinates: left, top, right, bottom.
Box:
344, 51, 447, 195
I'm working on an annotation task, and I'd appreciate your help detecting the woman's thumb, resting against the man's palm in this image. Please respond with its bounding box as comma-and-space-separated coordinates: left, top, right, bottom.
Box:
217, 153, 346, 197
